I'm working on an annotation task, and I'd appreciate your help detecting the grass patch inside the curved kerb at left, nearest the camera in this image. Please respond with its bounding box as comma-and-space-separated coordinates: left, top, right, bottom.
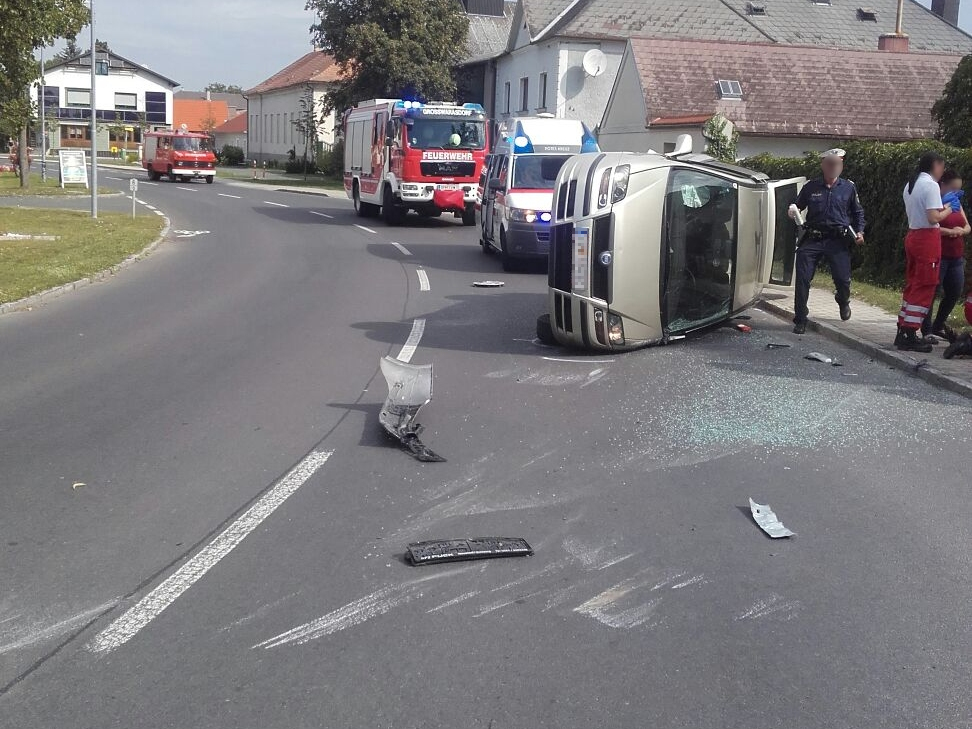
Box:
0, 208, 163, 303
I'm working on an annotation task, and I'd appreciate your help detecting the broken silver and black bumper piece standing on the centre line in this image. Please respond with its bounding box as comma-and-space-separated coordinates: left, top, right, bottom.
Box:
378, 357, 445, 463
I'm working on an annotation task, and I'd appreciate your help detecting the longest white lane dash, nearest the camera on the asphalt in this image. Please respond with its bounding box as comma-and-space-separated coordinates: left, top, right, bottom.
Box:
88, 451, 332, 653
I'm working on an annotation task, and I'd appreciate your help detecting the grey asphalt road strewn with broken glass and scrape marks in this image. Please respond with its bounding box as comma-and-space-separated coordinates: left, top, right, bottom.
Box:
0, 168, 972, 729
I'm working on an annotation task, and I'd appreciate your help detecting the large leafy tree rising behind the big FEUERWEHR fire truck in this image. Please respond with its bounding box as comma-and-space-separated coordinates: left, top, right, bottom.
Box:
307, 0, 469, 113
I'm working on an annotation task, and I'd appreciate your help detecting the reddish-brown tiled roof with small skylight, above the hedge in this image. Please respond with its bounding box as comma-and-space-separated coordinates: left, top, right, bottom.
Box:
631, 38, 961, 141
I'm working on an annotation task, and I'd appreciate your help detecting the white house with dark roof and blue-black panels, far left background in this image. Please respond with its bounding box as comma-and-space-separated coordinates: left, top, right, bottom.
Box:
32, 51, 179, 155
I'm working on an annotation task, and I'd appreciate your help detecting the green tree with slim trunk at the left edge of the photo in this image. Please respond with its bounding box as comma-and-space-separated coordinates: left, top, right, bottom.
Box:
0, 0, 88, 187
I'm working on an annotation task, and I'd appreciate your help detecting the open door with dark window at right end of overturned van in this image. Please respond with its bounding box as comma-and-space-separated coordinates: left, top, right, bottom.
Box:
759, 177, 807, 289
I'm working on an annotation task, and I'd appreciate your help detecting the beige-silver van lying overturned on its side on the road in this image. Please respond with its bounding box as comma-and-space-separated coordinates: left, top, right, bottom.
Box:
537, 145, 805, 350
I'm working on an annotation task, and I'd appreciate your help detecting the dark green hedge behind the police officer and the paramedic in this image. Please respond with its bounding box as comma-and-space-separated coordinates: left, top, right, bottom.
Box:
742, 140, 972, 286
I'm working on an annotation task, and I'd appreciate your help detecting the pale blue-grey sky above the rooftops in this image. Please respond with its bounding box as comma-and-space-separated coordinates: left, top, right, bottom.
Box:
49, 0, 972, 90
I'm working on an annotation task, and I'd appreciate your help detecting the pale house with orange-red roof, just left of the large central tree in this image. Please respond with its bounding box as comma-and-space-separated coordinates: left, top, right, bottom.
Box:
244, 50, 341, 162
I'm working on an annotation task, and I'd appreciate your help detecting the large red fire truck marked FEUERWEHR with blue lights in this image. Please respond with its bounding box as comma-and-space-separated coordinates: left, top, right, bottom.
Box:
344, 99, 487, 225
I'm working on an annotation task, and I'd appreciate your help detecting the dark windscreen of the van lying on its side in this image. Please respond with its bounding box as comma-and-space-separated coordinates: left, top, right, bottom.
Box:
661, 167, 739, 335
